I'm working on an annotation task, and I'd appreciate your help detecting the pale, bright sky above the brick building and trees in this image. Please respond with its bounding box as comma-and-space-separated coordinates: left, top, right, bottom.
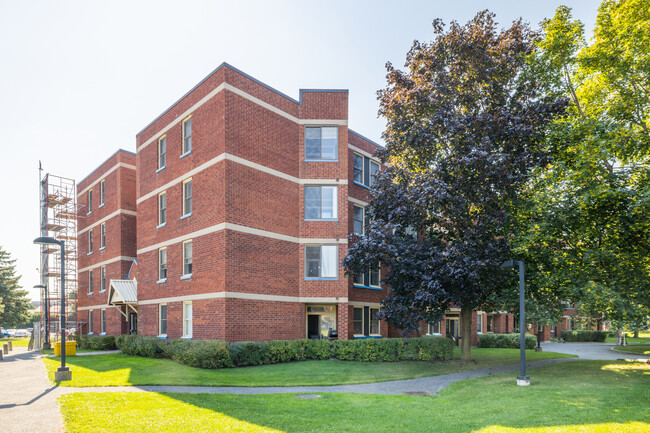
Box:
0, 0, 599, 299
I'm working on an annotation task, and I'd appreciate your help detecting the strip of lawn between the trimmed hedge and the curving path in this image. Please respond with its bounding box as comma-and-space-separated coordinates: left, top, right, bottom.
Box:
43, 348, 573, 386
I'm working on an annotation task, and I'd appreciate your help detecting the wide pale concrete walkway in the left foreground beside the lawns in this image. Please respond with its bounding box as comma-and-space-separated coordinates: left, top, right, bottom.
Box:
0, 347, 63, 433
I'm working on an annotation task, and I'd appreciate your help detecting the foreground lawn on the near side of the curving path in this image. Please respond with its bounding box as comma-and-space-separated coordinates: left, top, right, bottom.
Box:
59, 361, 650, 433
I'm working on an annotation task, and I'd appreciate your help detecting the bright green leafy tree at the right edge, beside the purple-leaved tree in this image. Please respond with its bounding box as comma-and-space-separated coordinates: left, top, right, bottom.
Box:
516, 0, 650, 334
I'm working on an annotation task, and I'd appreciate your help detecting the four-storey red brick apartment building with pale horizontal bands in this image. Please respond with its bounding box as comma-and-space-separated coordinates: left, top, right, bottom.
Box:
78, 63, 513, 342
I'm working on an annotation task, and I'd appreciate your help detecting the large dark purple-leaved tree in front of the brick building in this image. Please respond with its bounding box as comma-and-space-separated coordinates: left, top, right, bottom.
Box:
344, 11, 565, 360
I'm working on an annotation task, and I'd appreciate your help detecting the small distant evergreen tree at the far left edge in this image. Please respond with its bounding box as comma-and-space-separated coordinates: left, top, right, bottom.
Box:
0, 247, 32, 327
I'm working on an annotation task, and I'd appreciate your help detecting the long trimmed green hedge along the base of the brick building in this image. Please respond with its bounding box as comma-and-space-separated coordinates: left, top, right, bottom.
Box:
115, 335, 453, 369
